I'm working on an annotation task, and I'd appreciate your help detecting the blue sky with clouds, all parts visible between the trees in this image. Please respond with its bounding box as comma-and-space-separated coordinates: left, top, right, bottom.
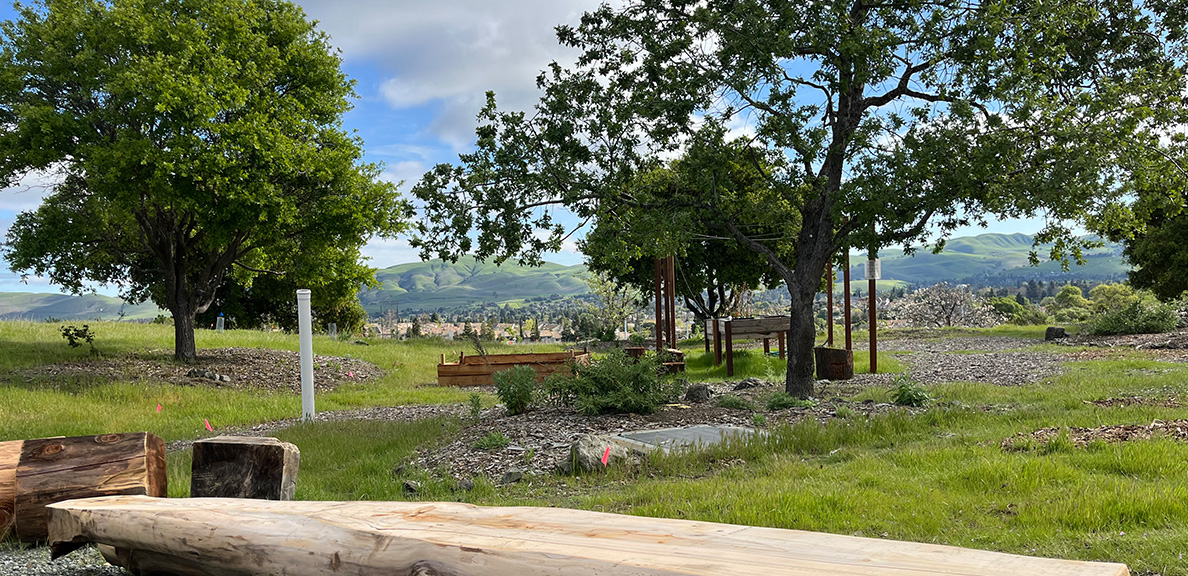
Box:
0, 0, 1042, 295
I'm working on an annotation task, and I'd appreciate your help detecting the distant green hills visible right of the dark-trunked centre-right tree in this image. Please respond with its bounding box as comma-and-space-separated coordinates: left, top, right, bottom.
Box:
851, 234, 1130, 286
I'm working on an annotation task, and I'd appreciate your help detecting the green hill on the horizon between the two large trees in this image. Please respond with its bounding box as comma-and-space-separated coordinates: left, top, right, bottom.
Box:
359, 257, 588, 315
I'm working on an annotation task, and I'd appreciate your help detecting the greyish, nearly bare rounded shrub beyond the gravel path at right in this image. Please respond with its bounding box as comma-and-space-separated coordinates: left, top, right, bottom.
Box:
887, 281, 1001, 328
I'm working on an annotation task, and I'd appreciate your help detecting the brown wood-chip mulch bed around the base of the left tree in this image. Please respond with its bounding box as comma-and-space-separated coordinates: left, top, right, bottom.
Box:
12, 348, 384, 392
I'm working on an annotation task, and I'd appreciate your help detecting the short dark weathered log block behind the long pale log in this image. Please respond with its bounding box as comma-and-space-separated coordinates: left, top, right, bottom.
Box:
190, 436, 301, 500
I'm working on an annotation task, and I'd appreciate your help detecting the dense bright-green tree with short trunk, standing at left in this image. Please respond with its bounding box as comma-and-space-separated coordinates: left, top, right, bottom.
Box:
0, 0, 406, 360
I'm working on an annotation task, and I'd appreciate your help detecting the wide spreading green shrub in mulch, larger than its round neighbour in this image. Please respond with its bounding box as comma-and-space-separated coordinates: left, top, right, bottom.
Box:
544, 349, 684, 414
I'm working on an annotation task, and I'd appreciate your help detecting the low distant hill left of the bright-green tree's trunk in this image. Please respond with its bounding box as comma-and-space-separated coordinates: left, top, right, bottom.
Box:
0, 292, 169, 321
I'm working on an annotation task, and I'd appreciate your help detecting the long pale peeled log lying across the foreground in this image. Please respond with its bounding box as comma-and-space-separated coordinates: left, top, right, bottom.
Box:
50, 496, 1129, 576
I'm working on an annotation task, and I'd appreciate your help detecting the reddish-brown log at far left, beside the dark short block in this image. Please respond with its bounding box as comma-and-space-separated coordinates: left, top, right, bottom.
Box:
14, 432, 166, 542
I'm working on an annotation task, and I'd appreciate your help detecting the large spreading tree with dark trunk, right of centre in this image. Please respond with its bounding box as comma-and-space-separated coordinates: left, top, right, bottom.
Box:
415, 0, 1186, 397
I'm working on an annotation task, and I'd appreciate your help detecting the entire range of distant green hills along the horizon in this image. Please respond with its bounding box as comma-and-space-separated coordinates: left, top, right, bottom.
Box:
0, 234, 1130, 319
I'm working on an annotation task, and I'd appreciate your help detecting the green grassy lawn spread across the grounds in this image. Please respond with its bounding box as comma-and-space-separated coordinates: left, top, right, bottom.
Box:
0, 323, 1188, 575
